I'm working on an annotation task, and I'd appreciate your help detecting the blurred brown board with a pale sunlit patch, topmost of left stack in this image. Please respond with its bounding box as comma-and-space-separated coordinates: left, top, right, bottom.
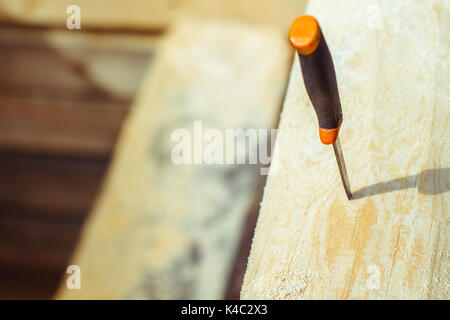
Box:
0, 28, 159, 101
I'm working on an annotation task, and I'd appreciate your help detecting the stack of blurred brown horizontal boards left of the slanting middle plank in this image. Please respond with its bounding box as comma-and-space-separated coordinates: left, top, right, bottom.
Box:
0, 28, 151, 299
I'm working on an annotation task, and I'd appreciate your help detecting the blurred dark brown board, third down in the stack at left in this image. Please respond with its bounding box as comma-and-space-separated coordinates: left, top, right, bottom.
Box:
0, 153, 107, 215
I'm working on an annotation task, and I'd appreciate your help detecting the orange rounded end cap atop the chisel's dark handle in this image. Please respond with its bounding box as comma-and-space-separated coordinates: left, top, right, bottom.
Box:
289, 15, 322, 55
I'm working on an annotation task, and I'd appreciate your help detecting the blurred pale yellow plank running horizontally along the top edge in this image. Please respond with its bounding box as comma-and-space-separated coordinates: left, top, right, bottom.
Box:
0, 0, 306, 32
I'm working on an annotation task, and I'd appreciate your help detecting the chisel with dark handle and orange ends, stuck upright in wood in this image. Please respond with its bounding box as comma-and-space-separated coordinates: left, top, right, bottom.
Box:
289, 15, 352, 200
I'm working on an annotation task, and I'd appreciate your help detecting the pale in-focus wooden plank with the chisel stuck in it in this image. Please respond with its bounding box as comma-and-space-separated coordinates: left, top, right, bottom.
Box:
241, 0, 450, 299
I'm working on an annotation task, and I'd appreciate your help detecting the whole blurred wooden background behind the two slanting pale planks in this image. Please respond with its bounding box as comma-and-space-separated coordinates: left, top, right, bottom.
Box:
0, 0, 306, 298
